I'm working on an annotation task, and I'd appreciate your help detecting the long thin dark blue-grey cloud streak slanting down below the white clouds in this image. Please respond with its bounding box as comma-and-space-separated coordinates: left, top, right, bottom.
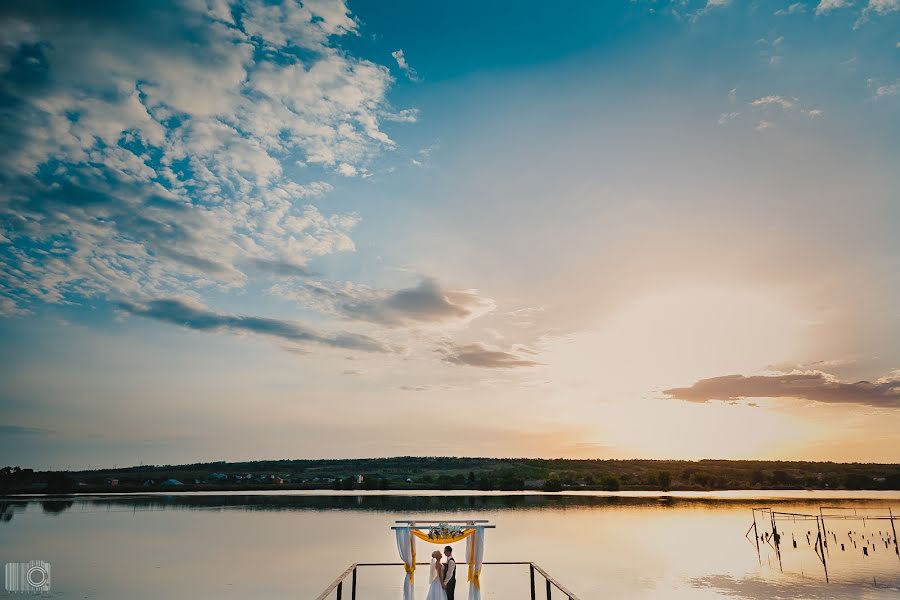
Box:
119, 298, 389, 352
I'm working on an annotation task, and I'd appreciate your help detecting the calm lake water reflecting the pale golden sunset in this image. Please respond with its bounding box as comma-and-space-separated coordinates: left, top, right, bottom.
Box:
0, 492, 900, 600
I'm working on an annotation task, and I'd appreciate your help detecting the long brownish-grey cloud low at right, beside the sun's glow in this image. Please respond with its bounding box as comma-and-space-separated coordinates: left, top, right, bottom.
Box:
663, 371, 900, 408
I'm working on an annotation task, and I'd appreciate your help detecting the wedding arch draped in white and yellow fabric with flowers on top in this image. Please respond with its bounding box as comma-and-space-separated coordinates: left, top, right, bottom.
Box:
391, 519, 496, 600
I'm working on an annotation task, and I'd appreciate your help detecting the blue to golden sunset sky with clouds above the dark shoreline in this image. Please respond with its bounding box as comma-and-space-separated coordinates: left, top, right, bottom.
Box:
0, 0, 900, 468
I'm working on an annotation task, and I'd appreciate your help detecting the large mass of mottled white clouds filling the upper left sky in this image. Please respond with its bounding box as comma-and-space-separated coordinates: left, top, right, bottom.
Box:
0, 0, 400, 312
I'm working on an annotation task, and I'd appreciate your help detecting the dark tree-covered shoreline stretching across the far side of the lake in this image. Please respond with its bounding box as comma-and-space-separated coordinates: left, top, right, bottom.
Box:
0, 457, 900, 494
